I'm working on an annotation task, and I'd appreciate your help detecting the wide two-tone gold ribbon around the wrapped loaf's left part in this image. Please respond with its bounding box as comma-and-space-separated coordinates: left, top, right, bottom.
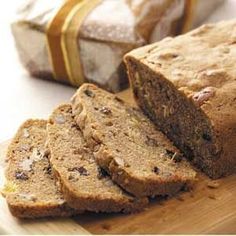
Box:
47, 0, 102, 86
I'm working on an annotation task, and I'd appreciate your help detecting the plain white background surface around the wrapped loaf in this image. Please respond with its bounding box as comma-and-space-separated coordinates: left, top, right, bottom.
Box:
0, 0, 236, 142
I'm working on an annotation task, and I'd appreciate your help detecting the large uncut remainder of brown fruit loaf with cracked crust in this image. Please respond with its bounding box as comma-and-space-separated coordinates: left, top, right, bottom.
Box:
125, 20, 236, 178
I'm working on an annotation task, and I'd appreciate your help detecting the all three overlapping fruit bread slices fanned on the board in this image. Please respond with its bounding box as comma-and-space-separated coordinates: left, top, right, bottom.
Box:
3, 84, 196, 218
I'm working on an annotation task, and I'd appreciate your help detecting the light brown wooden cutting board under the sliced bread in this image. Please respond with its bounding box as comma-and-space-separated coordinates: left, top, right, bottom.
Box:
0, 91, 236, 234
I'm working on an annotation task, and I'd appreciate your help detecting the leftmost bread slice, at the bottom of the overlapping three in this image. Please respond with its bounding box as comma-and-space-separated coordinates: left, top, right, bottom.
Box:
3, 120, 76, 218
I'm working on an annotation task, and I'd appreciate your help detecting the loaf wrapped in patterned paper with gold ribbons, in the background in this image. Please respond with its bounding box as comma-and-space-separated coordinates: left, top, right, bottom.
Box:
12, 0, 222, 92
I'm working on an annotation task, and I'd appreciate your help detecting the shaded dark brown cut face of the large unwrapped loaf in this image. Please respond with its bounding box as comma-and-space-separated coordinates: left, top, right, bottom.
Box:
127, 57, 220, 177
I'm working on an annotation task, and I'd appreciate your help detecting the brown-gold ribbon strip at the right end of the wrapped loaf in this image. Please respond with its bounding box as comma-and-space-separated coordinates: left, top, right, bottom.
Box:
181, 0, 198, 33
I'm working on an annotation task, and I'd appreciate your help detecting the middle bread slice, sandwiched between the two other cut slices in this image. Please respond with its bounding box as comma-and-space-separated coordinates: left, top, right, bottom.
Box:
47, 104, 148, 212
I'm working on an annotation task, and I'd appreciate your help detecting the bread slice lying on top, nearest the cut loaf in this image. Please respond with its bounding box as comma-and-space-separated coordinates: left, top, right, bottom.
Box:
72, 84, 196, 197
